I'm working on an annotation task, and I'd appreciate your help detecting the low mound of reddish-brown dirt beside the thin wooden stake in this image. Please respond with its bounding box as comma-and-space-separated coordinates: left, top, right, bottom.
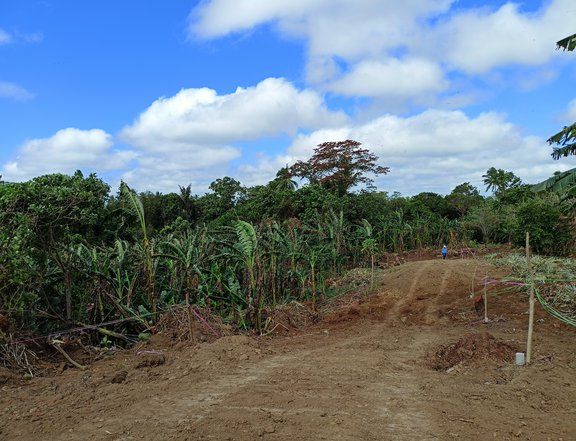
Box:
429, 332, 518, 371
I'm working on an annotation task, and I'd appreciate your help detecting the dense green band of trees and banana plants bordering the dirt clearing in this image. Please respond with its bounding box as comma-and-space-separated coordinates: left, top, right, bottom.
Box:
0, 144, 573, 336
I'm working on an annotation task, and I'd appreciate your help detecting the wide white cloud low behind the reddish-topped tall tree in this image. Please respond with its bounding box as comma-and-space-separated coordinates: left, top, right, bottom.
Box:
234, 109, 570, 195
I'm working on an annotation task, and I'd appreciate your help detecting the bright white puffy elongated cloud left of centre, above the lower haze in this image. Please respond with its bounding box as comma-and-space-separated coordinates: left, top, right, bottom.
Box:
121, 78, 346, 151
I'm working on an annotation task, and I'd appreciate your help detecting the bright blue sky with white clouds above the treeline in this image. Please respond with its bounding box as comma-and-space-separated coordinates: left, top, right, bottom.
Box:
0, 0, 576, 195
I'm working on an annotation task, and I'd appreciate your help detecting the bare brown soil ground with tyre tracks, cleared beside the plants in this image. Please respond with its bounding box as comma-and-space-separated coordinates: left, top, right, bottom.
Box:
0, 259, 576, 441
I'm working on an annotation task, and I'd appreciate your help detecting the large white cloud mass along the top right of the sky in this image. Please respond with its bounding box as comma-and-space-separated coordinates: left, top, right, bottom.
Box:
189, 0, 576, 99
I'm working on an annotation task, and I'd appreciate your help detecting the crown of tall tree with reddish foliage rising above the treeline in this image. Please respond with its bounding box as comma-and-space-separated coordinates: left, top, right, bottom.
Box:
289, 139, 390, 196
